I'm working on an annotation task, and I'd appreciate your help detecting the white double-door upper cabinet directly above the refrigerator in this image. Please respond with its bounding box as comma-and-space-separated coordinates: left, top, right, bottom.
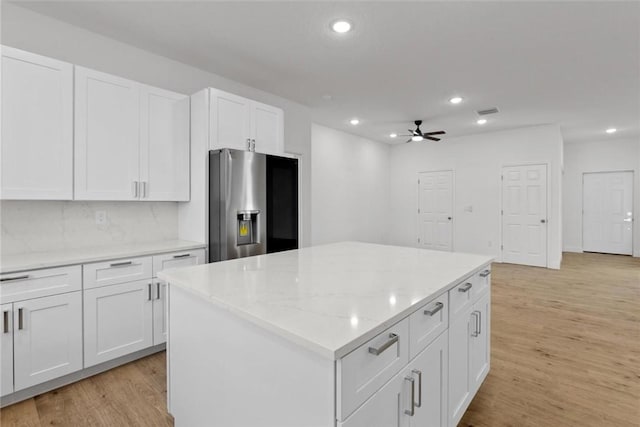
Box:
209, 89, 284, 154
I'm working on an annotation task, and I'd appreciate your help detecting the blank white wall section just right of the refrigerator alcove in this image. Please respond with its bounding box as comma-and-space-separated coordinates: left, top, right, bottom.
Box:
311, 124, 390, 245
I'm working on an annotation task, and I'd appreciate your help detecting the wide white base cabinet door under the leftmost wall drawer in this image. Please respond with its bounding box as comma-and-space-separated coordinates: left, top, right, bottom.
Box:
13, 291, 82, 391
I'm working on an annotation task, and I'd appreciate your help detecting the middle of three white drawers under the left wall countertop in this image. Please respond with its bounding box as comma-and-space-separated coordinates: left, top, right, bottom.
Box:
83, 257, 152, 289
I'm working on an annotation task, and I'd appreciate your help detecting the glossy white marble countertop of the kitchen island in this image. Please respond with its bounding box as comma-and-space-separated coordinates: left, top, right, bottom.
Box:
158, 242, 493, 360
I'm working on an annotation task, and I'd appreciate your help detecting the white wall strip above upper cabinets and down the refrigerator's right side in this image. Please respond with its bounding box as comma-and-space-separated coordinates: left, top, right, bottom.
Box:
0, 2, 311, 246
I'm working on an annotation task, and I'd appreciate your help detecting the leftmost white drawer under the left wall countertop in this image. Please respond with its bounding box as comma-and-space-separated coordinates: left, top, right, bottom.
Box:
0, 265, 82, 304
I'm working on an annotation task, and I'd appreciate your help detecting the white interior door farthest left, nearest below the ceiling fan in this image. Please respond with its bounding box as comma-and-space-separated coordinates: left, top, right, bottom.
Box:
418, 170, 453, 251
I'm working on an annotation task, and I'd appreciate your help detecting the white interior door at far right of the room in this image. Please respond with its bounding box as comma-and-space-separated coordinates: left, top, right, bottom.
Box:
582, 172, 633, 255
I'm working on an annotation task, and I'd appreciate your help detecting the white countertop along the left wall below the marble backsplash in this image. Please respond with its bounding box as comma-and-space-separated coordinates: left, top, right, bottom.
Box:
0, 240, 206, 273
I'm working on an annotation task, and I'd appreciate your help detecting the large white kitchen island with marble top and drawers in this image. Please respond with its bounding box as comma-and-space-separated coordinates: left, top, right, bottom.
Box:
160, 242, 492, 427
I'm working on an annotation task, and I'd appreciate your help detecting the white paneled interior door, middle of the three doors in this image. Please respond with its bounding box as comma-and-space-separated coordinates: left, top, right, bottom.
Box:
502, 165, 547, 267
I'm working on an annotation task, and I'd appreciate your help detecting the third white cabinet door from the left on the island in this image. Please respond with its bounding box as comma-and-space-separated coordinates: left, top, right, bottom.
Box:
448, 307, 473, 426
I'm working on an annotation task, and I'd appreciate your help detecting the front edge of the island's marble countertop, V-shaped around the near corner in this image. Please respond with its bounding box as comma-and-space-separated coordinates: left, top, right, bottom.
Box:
158, 257, 494, 361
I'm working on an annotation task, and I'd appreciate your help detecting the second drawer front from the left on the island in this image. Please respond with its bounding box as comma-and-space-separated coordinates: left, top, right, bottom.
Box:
409, 292, 449, 359
